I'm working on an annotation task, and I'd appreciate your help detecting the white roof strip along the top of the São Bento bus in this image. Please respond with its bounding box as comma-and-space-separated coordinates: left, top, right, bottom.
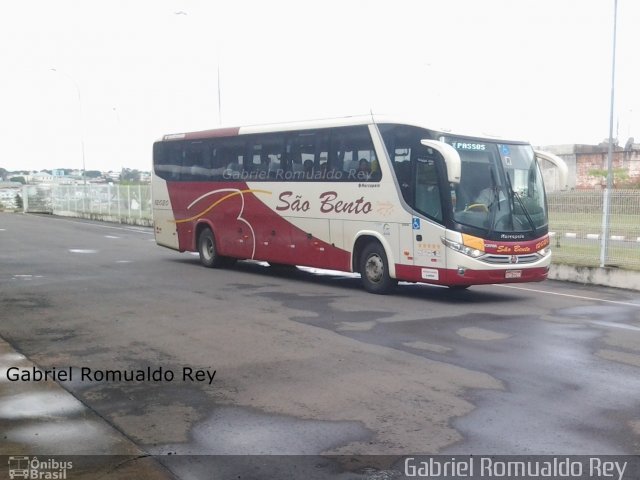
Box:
162, 115, 528, 144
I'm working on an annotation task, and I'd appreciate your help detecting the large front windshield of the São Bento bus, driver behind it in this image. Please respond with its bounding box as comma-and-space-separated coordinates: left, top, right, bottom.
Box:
444, 137, 547, 238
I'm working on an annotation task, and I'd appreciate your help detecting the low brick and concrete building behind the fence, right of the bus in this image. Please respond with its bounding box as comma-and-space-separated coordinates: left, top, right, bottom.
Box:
540, 139, 640, 189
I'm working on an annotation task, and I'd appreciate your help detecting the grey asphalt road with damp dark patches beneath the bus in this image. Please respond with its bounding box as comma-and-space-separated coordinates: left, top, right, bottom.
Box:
0, 214, 640, 478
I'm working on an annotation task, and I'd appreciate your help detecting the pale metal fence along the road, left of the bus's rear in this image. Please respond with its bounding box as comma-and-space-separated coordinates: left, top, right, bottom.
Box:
23, 184, 153, 225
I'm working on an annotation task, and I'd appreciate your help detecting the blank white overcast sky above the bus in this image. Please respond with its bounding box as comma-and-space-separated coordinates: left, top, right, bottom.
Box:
0, 0, 640, 171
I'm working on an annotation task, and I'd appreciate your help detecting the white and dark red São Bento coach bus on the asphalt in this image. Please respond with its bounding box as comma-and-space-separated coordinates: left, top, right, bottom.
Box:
153, 116, 568, 293
